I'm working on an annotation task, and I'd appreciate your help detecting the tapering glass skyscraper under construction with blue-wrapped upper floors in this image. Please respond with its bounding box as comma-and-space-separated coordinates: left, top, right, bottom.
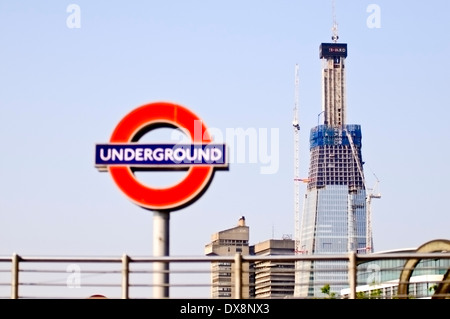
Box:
296, 36, 372, 297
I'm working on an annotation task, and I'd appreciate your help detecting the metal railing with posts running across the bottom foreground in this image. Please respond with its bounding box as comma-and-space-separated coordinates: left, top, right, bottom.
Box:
0, 252, 450, 299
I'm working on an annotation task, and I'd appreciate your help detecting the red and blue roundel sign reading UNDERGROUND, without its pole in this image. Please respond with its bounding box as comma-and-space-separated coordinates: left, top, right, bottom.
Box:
95, 102, 228, 212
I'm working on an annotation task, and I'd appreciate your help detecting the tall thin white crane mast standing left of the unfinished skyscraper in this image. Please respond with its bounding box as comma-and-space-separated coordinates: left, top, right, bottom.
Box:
292, 64, 302, 254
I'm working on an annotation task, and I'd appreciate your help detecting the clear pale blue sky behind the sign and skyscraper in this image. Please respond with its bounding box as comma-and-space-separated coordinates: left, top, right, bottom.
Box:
0, 0, 450, 264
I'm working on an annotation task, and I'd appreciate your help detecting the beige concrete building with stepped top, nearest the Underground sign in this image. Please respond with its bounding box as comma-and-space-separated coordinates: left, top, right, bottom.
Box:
205, 216, 250, 298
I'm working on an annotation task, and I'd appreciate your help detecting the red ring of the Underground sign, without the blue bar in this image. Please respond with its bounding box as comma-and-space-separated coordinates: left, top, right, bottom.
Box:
109, 102, 214, 211
